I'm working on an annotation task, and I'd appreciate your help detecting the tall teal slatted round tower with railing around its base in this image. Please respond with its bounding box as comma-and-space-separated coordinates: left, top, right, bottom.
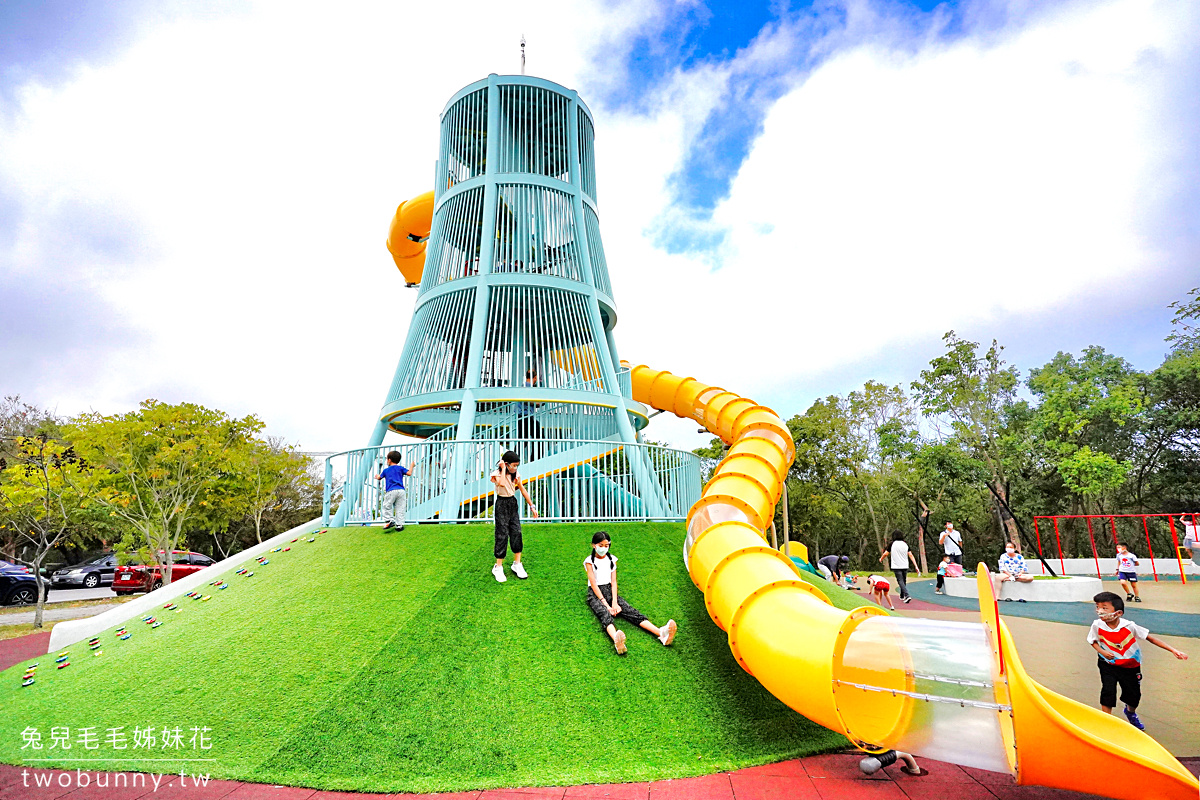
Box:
325, 74, 701, 524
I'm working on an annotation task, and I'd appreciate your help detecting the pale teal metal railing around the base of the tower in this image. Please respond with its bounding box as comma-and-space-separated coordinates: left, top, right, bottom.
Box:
324, 439, 701, 525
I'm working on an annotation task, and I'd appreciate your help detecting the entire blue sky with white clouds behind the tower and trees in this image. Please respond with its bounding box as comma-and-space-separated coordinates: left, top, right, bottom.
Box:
0, 0, 1200, 450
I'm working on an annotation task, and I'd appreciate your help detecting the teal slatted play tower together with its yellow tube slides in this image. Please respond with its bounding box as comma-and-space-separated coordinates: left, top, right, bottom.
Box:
325, 76, 1198, 799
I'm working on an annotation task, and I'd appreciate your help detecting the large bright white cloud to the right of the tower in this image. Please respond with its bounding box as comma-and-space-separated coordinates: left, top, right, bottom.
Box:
605, 1, 1200, 450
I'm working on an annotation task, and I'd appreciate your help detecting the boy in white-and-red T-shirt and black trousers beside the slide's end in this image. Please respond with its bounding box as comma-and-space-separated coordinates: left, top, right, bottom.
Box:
1087, 591, 1188, 730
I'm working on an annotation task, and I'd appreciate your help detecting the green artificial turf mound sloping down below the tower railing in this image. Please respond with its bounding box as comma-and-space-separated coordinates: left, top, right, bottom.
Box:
0, 523, 849, 792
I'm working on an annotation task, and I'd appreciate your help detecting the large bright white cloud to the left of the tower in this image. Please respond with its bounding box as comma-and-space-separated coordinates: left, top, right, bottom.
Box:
0, 2, 647, 447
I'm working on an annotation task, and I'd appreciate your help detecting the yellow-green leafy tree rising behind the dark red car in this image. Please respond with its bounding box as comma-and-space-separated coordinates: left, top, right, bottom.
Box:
71, 399, 263, 584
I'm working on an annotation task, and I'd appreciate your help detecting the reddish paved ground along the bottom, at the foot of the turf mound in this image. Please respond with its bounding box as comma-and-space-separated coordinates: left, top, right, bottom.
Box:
0, 753, 1200, 800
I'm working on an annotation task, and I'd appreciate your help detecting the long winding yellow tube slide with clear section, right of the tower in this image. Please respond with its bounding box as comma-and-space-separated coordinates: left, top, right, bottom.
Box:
625, 365, 1200, 800
